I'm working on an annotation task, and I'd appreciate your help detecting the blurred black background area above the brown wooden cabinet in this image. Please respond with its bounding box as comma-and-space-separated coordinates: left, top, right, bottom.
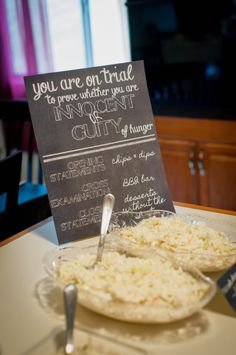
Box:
127, 0, 236, 119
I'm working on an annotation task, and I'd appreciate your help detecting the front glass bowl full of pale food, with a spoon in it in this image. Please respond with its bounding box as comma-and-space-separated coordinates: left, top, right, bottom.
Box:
44, 243, 216, 323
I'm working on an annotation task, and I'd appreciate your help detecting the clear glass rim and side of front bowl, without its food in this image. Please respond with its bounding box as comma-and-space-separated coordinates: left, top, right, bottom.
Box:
43, 241, 216, 324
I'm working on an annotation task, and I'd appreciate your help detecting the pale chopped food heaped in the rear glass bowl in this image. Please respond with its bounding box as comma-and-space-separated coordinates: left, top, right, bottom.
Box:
118, 216, 236, 271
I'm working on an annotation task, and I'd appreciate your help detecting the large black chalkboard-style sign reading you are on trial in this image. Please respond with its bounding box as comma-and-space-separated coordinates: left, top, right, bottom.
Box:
25, 61, 174, 243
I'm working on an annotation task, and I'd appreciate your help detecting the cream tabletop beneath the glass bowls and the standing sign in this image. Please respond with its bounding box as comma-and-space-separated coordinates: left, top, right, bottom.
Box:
0, 204, 236, 355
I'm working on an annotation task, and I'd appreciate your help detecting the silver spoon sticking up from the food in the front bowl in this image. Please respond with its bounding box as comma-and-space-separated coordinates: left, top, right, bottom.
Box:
89, 194, 115, 268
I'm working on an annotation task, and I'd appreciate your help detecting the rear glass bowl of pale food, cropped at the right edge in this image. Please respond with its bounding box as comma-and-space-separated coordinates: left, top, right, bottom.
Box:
109, 210, 236, 272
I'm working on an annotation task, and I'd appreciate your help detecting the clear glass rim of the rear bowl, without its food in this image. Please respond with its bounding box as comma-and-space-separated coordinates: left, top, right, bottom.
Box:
109, 210, 236, 272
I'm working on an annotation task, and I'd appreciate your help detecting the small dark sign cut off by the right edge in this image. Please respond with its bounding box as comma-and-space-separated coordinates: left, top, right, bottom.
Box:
217, 264, 236, 311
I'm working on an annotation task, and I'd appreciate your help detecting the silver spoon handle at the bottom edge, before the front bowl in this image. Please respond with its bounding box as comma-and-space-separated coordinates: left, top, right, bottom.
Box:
63, 284, 77, 354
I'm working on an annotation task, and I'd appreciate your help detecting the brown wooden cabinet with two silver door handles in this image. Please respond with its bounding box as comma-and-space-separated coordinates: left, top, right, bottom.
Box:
155, 117, 236, 210
